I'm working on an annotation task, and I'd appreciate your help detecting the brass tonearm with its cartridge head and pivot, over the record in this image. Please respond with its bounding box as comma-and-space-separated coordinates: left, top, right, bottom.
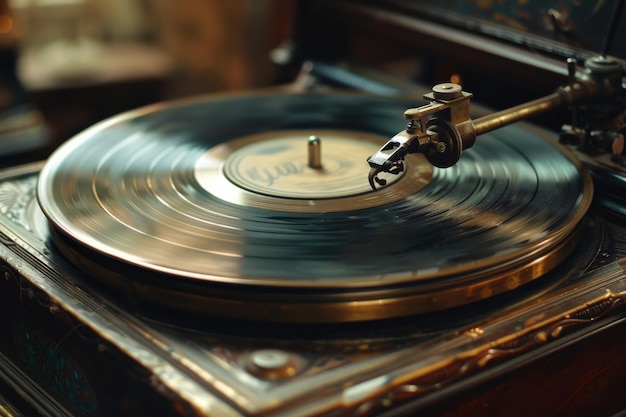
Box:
367, 56, 624, 189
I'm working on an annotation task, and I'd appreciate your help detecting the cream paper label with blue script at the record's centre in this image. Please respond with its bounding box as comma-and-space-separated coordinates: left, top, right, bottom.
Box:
196, 130, 408, 199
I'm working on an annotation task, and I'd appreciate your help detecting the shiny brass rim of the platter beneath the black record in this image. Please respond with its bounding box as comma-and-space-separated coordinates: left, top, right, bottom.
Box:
53, 221, 581, 324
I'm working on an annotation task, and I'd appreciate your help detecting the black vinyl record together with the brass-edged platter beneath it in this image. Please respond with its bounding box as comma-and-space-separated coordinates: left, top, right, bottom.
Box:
38, 94, 592, 321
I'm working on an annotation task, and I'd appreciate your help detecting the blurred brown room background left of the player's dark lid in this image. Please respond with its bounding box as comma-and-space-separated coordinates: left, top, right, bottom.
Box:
0, 0, 294, 158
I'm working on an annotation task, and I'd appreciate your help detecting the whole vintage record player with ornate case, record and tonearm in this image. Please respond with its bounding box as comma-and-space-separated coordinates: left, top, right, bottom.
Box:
0, 1, 626, 416
